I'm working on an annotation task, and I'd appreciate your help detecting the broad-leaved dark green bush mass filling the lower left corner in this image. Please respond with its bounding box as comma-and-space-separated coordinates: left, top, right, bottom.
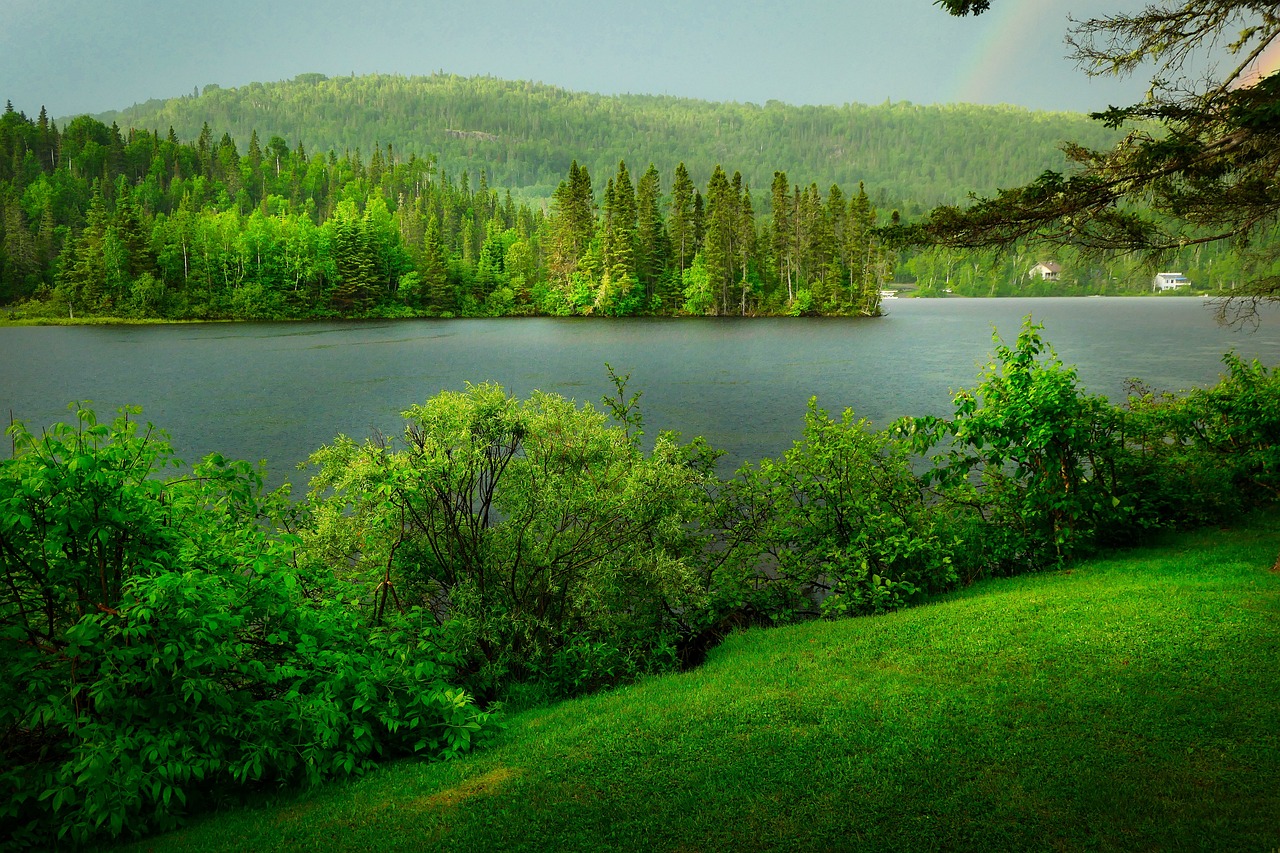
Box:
0, 409, 493, 847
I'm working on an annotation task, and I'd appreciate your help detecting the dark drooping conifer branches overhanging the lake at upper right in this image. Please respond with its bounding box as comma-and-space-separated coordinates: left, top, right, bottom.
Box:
906, 0, 1280, 301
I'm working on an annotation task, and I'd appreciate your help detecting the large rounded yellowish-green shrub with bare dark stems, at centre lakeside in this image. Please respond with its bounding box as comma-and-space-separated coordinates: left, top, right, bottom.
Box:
303, 384, 707, 694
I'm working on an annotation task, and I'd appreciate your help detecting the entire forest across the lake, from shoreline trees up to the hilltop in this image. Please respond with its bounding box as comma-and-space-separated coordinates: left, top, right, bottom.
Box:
0, 76, 1266, 319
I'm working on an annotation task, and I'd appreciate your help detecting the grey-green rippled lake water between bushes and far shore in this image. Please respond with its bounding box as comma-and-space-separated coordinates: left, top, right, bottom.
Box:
0, 297, 1280, 483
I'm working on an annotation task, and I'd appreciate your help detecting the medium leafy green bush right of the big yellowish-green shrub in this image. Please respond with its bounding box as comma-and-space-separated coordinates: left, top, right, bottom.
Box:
726, 400, 955, 619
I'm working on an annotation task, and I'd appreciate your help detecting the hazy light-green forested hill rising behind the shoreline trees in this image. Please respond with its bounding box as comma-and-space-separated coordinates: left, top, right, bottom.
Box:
92, 74, 1115, 207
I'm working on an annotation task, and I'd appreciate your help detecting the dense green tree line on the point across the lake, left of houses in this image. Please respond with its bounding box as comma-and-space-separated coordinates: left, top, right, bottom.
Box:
0, 105, 893, 319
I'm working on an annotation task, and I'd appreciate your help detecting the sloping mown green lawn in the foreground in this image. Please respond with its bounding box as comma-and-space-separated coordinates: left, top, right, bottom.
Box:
124, 515, 1280, 852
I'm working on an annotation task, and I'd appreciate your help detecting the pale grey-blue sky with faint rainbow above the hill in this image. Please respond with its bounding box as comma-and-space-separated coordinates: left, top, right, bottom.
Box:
0, 0, 1198, 118
